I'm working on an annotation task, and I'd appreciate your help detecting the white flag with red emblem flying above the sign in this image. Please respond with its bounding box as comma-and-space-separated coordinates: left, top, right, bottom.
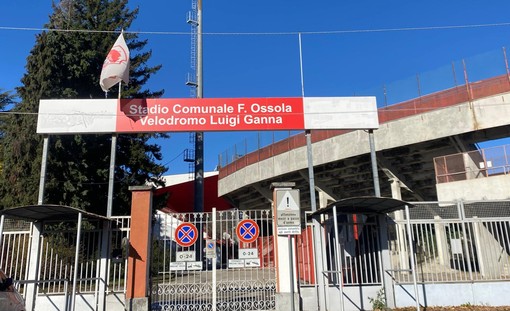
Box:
99, 33, 129, 92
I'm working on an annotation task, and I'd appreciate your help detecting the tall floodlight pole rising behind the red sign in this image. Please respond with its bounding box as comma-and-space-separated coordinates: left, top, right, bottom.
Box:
193, 0, 204, 212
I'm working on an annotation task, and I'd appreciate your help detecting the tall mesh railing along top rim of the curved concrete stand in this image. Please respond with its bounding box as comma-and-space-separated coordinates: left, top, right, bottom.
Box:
218, 48, 510, 174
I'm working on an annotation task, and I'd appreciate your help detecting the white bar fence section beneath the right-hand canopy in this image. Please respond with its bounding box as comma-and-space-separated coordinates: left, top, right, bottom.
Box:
296, 214, 382, 286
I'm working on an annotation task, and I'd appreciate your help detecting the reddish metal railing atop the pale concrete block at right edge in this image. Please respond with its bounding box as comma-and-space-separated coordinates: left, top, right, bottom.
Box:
434, 145, 510, 184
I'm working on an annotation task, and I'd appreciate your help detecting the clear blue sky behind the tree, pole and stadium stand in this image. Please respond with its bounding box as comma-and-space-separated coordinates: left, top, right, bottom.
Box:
0, 0, 510, 174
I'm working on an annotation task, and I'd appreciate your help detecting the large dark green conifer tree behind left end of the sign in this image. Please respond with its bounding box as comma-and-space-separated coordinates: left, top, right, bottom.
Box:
0, 0, 166, 215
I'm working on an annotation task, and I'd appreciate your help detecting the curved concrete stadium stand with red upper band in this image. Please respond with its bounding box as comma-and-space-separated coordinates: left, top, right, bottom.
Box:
218, 75, 510, 210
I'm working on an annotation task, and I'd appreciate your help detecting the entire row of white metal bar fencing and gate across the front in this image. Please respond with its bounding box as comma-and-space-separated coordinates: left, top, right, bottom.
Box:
0, 200, 510, 302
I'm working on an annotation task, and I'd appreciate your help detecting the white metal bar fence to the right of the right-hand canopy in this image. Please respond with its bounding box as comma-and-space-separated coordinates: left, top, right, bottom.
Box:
390, 201, 510, 283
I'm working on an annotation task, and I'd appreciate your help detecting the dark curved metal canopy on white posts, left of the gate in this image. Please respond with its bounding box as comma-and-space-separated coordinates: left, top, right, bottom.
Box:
0, 204, 110, 310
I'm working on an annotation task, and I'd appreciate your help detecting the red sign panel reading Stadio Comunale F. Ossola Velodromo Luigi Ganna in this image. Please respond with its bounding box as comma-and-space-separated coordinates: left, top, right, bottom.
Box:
117, 98, 304, 132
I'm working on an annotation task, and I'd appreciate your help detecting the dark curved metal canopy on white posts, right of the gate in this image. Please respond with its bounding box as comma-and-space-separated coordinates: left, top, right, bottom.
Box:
309, 196, 420, 311
